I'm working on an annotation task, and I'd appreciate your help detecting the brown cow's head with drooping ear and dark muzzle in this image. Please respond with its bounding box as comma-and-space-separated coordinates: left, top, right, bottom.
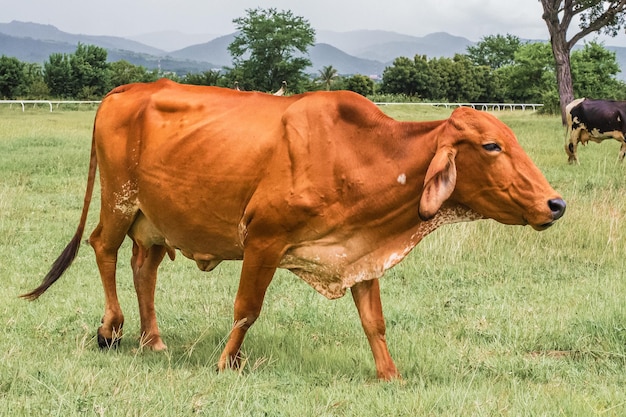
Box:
419, 108, 565, 230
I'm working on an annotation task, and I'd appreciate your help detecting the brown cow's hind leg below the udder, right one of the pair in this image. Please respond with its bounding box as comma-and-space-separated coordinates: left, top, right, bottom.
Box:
131, 241, 167, 350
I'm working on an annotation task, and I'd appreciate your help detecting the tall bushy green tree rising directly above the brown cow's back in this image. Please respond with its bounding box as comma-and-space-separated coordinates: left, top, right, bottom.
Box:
228, 8, 315, 92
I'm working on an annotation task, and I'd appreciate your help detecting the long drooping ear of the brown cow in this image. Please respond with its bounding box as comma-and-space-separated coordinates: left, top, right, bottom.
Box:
419, 146, 456, 221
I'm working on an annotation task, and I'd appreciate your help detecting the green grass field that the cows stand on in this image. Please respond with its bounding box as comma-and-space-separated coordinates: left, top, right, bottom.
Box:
0, 101, 626, 417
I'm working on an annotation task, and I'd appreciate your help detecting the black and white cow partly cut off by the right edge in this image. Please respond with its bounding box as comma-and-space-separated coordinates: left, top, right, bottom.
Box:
565, 98, 626, 164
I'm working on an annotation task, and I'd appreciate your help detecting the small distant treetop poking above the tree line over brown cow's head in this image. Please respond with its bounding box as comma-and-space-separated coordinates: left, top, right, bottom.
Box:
467, 34, 522, 70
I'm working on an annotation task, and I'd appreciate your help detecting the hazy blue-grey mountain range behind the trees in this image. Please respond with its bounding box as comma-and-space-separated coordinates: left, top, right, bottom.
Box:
0, 21, 626, 80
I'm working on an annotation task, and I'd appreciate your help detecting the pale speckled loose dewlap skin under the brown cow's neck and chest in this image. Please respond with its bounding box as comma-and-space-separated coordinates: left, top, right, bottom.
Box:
279, 203, 483, 299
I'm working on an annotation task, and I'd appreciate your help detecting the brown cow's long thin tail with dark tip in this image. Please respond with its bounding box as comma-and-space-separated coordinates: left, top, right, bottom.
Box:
20, 123, 98, 301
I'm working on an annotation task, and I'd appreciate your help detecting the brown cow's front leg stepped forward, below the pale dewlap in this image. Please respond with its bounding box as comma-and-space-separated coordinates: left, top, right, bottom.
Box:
352, 279, 400, 380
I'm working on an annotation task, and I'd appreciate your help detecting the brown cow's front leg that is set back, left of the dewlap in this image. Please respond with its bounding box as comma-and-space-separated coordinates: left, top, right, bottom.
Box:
217, 240, 282, 371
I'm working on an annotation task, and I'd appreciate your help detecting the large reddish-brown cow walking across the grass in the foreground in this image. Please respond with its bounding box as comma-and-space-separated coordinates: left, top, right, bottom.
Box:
24, 80, 565, 379
